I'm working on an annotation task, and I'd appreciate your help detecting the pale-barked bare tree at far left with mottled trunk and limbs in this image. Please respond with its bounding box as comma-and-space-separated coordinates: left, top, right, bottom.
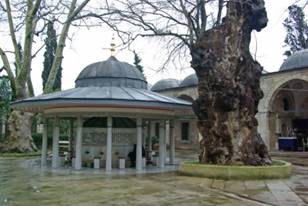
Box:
0, 0, 106, 152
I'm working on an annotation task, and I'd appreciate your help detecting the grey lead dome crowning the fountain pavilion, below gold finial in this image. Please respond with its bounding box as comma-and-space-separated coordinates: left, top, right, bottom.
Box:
75, 56, 147, 89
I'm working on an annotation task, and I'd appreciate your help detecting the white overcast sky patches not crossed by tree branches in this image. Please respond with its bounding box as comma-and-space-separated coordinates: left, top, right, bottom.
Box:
0, 0, 304, 95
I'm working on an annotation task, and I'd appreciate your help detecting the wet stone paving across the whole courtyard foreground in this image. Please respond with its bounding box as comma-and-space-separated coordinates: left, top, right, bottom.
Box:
0, 156, 308, 206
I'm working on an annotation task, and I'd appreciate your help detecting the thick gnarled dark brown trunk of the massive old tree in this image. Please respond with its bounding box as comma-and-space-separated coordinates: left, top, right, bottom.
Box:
191, 0, 271, 165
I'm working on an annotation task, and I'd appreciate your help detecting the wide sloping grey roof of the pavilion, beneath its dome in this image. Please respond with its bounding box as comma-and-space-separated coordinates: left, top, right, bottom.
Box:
12, 86, 192, 112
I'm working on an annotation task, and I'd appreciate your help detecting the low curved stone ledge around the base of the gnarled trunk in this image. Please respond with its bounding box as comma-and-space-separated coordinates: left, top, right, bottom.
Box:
179, 160, 292, 180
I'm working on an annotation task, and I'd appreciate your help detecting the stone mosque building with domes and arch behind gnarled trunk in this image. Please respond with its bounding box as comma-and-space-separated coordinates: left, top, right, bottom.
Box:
151, 49, 308, 151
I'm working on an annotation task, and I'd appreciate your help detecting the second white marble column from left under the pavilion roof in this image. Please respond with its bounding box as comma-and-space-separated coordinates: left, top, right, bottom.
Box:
51, 117, 60, 168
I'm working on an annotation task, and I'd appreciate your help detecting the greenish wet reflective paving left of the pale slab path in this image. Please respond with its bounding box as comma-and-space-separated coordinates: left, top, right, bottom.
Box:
0, 159, 264, 206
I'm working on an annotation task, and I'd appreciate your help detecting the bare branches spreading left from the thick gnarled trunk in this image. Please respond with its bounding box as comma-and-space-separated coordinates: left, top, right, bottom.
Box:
109, 0, 226, 68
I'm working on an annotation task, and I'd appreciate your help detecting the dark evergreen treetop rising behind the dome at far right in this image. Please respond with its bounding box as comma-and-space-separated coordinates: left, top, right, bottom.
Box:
283, 5, 308, 56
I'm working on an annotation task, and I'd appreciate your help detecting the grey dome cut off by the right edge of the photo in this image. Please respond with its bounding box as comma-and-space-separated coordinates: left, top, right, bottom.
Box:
279, 49, 308, 71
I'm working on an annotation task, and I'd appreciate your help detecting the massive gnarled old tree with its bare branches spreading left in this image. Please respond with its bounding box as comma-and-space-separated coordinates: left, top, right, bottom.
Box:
110, 0, 271, 165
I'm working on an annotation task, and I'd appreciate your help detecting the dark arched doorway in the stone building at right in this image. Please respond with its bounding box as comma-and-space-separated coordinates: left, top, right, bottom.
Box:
268, 79, 308, 150
